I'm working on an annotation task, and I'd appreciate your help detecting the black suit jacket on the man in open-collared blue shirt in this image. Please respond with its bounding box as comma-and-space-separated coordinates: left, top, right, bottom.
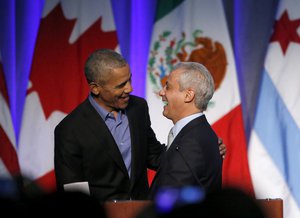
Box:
54, 96, 163, 201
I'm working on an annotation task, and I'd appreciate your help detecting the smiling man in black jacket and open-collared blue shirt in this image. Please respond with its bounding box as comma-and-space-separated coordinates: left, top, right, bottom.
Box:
54, 49, 226, 201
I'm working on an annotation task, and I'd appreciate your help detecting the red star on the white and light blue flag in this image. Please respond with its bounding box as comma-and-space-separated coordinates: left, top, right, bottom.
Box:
270, 10, 300, 54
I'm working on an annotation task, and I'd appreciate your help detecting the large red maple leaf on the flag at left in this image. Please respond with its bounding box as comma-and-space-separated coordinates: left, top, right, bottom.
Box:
28, 4, 118, 118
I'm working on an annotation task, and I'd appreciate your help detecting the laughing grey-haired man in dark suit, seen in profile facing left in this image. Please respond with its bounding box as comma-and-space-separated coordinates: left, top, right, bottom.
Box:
150, 62, 222, 198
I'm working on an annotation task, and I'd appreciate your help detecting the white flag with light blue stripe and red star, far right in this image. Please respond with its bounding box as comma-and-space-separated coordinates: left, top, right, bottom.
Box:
249, 0, 300, 218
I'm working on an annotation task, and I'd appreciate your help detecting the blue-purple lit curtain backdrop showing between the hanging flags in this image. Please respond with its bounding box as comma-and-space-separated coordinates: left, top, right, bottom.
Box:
0, 0, 278, 143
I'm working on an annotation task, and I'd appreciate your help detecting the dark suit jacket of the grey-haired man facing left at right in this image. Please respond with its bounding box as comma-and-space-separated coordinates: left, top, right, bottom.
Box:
150, 115, 222, 198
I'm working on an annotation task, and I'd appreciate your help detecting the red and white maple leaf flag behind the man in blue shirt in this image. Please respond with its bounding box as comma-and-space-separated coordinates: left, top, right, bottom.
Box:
18, 0, 118, 191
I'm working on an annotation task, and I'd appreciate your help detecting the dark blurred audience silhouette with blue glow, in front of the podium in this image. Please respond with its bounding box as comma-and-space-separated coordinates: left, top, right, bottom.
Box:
137, 187, 266, 218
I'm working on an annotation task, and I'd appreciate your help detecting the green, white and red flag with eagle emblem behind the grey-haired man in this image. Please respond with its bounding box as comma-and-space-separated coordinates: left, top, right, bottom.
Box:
146, 0, 253, 194
